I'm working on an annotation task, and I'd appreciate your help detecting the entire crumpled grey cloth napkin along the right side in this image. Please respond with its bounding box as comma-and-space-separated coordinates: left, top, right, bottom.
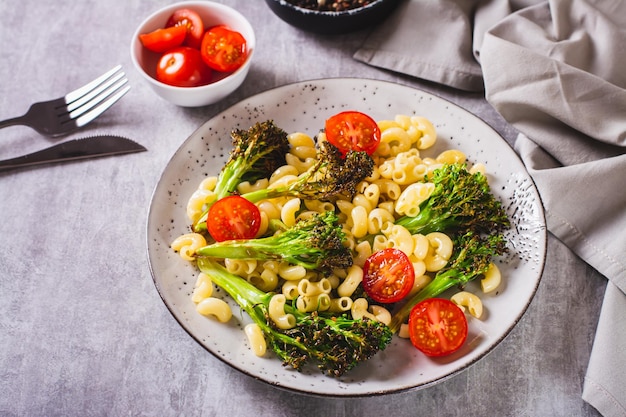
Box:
354, 0, 626, 417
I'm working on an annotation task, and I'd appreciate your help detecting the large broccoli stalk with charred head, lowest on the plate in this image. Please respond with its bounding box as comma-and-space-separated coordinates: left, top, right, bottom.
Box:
197, 258, 392, 377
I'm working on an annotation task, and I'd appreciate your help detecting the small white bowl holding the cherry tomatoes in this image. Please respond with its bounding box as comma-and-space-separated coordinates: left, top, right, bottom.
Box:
130, 1, 256, 107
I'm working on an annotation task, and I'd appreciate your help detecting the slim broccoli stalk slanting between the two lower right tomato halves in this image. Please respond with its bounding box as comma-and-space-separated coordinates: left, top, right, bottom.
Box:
389, 231, 507, 332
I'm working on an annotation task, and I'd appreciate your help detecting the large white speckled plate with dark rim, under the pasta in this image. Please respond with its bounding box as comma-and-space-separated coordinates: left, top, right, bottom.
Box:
147, 79, 546, 397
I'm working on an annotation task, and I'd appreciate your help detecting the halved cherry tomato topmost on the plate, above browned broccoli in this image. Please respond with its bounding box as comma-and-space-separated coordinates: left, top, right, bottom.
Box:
324, 111, 381, 155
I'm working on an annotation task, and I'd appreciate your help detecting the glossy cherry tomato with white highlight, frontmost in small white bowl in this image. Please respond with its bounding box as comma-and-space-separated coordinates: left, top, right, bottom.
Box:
156, 46, 211, 87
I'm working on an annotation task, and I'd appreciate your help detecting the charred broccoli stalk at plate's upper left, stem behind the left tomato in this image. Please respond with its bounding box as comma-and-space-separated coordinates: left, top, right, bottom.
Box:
193, 120, 289, 232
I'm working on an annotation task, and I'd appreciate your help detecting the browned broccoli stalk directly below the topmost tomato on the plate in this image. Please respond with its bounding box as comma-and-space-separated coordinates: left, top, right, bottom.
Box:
242, 141, 374, 203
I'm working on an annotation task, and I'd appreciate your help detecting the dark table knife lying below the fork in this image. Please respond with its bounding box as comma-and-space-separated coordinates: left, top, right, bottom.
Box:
0, 135, 147, 171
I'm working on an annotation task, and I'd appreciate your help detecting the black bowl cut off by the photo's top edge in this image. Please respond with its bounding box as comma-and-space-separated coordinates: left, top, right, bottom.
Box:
265, 0, 400, 35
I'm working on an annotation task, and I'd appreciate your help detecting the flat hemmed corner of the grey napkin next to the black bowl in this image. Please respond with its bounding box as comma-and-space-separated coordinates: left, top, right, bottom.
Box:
354, 0, 539, 91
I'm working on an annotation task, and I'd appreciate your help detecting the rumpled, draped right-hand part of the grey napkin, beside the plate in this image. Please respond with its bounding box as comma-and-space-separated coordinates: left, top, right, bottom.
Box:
480, 0, 626, 416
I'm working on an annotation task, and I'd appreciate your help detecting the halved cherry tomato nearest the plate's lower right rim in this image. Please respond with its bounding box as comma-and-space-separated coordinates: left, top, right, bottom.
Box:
409, 298, 467, 356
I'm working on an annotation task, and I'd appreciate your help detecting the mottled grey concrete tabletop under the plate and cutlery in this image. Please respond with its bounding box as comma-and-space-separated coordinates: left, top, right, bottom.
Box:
0, 0, 606, 417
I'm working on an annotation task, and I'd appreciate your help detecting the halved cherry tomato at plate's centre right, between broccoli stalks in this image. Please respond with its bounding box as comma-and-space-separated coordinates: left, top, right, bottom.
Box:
363, 248, 415, 303
